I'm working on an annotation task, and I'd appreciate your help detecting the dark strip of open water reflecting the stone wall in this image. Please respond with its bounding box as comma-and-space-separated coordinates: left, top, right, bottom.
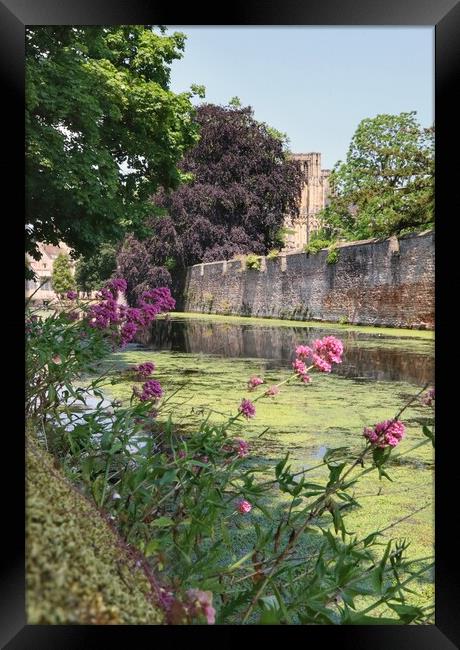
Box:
138, 319, 434, 385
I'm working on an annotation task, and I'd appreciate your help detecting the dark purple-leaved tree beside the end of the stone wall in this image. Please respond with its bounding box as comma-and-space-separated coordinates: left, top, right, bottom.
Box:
118, 101, 301, 302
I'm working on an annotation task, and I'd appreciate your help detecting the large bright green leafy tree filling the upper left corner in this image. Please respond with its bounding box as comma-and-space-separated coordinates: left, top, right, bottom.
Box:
25, 25, 203, 274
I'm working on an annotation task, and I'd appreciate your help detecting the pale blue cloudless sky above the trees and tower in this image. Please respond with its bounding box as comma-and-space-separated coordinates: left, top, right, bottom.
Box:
169, 26, 434, 169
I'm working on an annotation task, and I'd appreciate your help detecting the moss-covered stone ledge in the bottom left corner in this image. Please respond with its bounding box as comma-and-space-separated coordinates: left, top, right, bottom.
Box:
26, 436, 164, 625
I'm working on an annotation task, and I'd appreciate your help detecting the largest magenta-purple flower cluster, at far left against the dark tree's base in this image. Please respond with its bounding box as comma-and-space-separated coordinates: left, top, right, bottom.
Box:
88, 278, 176, 346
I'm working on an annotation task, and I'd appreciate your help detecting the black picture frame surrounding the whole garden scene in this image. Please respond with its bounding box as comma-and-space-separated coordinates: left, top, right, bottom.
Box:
4, 0, 460, 650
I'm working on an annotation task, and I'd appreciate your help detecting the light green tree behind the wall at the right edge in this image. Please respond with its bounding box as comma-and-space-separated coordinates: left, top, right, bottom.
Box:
320, 111, 434, 239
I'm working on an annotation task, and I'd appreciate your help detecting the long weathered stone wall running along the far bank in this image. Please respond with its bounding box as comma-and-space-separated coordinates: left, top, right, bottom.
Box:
184, 231, 434, 329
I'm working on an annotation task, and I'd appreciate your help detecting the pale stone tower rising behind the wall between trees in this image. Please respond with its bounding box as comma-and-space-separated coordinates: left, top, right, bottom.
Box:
284, 152, 331, 251
